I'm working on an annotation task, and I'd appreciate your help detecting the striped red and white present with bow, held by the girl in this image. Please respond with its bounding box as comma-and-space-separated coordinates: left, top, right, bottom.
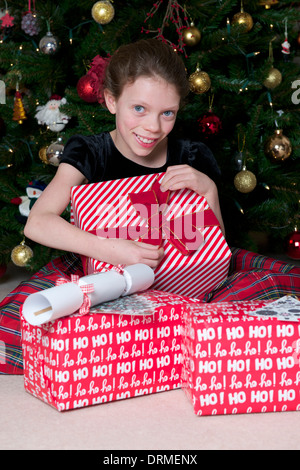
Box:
71, 173, 231, 298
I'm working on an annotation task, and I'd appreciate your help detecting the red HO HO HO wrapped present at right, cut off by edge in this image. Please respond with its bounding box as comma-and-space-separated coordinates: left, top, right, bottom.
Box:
182, 301, 300, 416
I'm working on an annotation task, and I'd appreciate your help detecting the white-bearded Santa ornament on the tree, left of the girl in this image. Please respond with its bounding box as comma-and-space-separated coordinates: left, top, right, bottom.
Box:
35, 95, 70, 132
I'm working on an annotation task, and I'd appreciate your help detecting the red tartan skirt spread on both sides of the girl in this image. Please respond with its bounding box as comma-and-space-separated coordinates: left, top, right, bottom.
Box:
0, 248, 300, 374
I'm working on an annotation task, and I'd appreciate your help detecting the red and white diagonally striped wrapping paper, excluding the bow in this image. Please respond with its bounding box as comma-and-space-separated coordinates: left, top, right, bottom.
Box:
71, 173, 231, 297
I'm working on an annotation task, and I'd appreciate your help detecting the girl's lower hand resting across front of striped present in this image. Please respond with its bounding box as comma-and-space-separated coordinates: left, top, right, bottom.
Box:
94, 238, 164, 269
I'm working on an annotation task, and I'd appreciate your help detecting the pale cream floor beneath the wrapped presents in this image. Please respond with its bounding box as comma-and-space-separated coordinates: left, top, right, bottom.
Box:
0, 258, 300, 450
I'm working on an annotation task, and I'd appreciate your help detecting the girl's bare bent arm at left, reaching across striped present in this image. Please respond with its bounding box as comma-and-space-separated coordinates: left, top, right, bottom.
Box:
24, 163, 163, 268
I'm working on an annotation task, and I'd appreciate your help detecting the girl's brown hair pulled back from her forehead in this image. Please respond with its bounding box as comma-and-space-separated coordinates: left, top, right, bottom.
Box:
103, 39, 189, 106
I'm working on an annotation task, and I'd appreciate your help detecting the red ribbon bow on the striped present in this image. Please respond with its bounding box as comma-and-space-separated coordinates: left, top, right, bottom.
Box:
129, 179, 220, 255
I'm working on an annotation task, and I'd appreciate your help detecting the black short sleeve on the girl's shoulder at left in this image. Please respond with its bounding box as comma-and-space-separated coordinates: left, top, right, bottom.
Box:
60, 134, 104, 182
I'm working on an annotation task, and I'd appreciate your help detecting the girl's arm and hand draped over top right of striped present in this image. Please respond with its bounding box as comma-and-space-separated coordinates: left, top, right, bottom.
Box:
161, 165, 225, 236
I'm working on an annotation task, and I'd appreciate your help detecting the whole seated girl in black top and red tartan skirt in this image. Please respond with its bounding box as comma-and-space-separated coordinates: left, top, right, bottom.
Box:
0, 39, 300, 374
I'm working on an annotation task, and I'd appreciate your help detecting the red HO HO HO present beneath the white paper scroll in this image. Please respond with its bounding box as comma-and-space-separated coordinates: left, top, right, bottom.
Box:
22, 290, 197, 411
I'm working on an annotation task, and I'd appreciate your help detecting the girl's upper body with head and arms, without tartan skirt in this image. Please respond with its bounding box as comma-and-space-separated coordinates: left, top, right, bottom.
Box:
24, 39, 224, 268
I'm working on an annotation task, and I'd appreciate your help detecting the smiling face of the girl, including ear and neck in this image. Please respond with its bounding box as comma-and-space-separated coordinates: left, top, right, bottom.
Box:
105, 76, 180, 167
